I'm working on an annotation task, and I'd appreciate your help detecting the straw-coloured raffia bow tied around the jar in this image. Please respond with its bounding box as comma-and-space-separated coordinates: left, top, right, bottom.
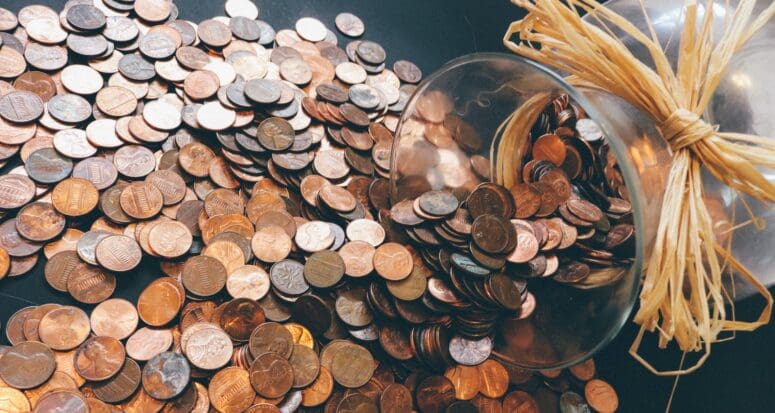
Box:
504, 0, 775, 375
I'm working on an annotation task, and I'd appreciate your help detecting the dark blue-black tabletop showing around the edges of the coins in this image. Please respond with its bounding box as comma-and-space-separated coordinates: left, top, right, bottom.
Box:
0, 0, 775, 412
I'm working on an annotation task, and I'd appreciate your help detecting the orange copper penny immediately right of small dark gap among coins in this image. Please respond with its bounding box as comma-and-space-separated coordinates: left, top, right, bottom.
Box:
137, 278, 183, 327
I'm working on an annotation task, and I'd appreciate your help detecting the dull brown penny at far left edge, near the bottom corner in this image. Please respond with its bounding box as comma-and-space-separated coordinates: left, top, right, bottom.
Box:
0, 341, 56, 389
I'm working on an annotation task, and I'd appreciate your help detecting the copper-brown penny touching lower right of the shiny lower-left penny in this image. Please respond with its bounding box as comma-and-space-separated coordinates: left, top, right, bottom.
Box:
75, 336, 126, 381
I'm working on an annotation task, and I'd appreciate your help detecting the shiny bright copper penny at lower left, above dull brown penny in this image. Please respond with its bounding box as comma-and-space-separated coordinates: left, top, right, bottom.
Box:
38, 306, 91, 351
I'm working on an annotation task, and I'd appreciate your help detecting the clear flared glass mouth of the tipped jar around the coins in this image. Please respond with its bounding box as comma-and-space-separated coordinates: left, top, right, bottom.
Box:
391, 54, 670, 369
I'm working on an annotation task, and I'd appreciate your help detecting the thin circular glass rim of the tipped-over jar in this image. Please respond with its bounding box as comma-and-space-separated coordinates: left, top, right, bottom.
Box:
391, 53, 647, 370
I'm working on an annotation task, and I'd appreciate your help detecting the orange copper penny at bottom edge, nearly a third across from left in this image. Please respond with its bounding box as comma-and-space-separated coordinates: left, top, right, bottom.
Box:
208, 366, 256, 412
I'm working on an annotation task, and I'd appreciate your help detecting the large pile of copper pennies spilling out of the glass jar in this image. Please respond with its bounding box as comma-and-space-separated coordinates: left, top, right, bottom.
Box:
0, 0, 623, 413
